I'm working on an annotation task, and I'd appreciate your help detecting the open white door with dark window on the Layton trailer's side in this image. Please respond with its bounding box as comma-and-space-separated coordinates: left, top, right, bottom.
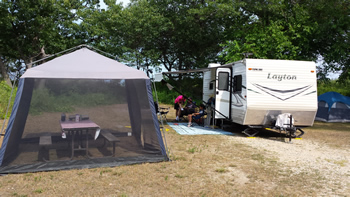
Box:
215, 68, 231, 119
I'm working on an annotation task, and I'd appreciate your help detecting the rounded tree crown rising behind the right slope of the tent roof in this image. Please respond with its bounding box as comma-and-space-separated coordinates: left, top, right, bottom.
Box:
102, 0, 171, 69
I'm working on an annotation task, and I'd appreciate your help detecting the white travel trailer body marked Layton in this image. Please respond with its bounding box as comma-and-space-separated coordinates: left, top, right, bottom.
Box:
203, 59, 317, 126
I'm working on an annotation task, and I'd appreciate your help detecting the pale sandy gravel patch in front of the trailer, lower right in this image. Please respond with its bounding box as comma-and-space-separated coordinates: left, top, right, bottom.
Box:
229, 137, 350, 196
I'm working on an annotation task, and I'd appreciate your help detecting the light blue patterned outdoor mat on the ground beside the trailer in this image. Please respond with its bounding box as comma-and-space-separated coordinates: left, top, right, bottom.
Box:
168, 122, 234, 135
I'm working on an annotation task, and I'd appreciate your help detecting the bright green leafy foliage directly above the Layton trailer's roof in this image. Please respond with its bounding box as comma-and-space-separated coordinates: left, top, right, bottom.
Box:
221, 0, 315, 62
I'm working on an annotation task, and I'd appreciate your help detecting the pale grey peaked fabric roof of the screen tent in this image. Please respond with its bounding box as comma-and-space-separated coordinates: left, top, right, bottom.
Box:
21, 48, 148, 79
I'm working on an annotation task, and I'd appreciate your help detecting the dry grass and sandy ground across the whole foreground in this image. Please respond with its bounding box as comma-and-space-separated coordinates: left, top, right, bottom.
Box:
0, 111, 350, 196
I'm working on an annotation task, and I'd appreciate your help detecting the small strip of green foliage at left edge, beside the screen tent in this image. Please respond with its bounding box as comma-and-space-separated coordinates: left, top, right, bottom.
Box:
0, 81, 17, 119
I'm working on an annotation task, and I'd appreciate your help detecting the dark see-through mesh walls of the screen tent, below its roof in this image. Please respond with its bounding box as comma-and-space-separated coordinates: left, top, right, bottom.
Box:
0, 78, 167, 173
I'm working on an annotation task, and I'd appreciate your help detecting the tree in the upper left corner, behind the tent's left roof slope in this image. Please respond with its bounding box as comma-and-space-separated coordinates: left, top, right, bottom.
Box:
0, 0, 98, 83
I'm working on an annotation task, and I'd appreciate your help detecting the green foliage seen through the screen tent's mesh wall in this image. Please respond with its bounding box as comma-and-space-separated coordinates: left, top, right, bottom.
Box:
29, 80, 125, 115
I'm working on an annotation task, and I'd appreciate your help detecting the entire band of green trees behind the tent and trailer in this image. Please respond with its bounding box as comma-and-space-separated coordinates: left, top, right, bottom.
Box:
0, 0, 350, 86
